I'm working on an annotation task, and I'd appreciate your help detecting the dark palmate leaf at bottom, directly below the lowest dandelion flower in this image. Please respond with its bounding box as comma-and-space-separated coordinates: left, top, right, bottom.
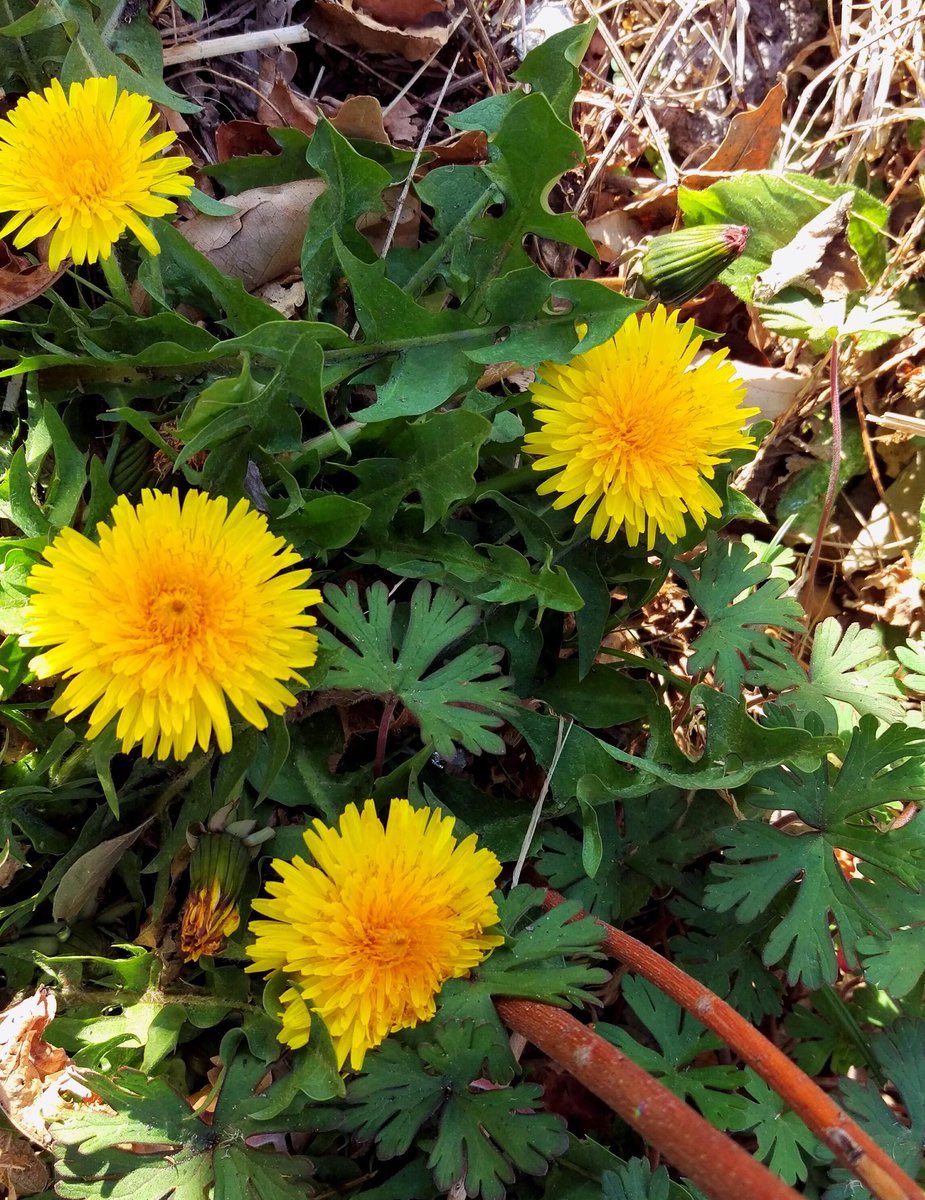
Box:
347, 1021, 569, 1200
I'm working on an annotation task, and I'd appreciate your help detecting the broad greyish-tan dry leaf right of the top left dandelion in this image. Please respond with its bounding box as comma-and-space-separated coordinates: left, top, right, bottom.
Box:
178, 179, 324, 292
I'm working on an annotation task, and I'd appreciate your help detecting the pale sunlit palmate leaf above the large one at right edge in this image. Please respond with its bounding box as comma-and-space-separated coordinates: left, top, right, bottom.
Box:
747, 617, 905, 733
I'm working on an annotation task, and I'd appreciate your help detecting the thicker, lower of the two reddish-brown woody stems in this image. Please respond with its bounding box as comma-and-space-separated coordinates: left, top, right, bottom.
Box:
495, 1000, 797, 1200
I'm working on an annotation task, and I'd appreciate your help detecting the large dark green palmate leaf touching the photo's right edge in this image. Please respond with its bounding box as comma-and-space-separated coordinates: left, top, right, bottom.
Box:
704, 716, 925, 988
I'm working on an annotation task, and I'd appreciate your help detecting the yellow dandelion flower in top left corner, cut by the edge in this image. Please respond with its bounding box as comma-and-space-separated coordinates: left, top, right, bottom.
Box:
0, 76, 193, 271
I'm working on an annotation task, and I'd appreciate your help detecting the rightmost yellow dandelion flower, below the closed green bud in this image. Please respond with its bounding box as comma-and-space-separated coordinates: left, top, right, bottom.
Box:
524, 305, 758, 550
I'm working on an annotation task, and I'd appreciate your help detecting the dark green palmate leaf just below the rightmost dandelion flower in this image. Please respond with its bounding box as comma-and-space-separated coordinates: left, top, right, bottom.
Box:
673, 533, 803, 692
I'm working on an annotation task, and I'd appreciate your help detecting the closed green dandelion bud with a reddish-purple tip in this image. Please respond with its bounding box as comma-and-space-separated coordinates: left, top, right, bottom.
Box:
642, 224, 749, 304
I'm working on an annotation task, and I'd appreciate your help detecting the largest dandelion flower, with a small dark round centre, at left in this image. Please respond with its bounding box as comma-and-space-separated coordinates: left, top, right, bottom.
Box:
20, 490, 322, 758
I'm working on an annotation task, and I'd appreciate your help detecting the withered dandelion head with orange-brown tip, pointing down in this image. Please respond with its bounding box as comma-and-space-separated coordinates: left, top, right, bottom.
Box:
180, 833, 251, 962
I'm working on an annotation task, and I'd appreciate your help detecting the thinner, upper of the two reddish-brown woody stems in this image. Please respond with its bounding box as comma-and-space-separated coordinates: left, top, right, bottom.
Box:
543, 889, 925, 1200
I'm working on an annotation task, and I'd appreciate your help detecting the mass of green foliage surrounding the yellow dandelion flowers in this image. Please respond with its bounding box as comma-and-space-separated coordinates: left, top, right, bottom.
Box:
0, 16, 925, 1200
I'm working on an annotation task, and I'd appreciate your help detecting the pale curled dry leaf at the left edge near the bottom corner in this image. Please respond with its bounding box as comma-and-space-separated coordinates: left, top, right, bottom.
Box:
0, 988, 92, 1148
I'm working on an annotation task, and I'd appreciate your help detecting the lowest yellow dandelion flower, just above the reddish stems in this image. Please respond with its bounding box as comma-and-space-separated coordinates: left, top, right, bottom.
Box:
247, 799, 504, 1070
